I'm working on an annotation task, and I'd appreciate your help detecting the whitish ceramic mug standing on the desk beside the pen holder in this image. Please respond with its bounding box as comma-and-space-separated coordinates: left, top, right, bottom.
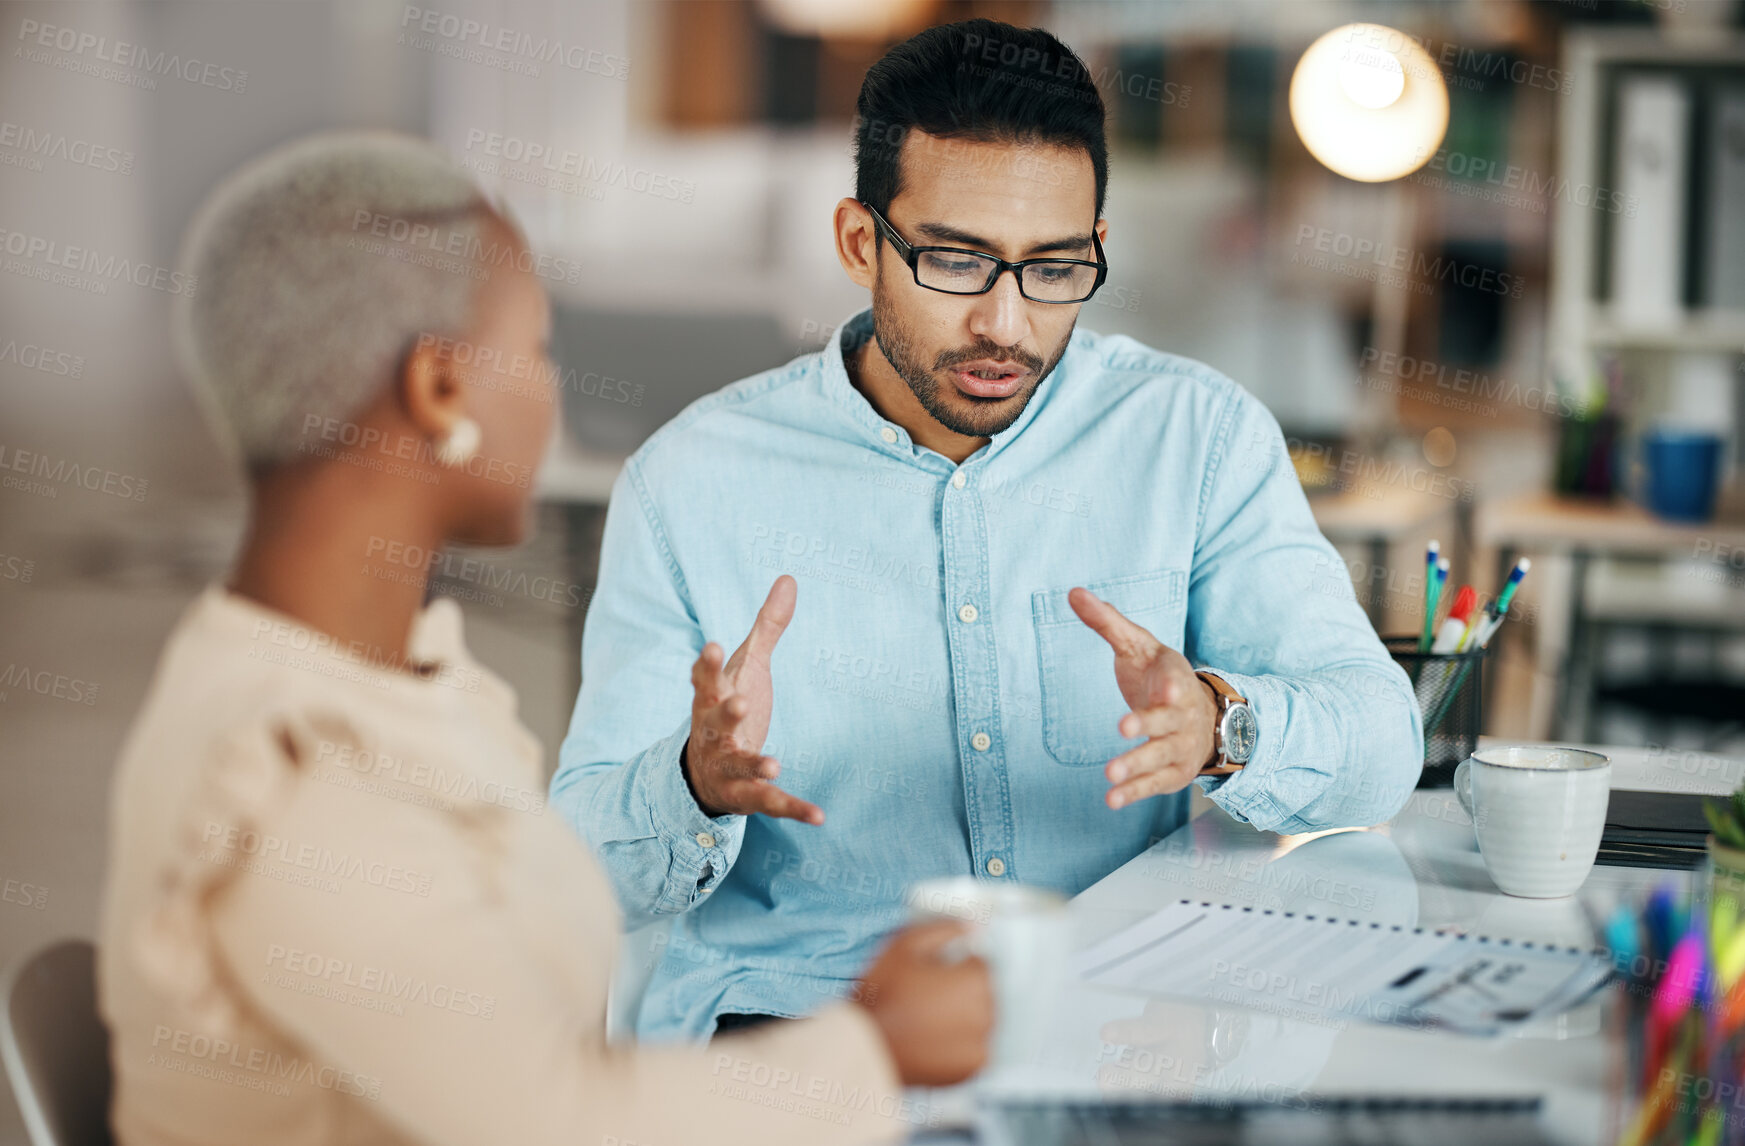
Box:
1454, 745, 1612, 900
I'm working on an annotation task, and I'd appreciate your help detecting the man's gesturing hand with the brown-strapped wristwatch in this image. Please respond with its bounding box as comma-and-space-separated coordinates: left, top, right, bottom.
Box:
1066, 590, 1218, 808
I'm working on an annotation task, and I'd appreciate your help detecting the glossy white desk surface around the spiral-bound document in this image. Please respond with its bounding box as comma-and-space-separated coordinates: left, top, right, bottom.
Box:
934, 748, 1745, 1144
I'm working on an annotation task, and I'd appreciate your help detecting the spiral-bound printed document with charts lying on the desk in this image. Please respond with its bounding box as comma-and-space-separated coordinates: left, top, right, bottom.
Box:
1075, 900, 1612, 1034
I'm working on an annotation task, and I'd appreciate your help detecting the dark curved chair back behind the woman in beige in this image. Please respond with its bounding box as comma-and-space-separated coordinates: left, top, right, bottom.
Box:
0, 938, 113, 1146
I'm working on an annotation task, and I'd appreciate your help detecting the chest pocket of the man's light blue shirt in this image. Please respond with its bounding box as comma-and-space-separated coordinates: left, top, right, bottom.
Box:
1030, 569, 1188, 766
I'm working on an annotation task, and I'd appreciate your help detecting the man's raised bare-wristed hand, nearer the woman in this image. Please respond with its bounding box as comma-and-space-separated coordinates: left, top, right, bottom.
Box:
679, 574, 824, 823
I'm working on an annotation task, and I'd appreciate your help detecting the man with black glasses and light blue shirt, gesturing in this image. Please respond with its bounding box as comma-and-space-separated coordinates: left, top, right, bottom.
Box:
551, 21, 1422, 1038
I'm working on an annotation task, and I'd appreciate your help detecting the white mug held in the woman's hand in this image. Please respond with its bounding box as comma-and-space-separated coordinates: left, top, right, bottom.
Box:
906, 876, 1073, 1068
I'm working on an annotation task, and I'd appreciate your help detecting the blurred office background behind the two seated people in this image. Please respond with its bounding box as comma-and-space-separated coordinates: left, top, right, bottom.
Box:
0, 0, 1745, 1143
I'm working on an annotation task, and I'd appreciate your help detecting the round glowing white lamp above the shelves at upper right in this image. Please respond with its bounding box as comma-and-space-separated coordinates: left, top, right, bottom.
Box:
1290, 24, 1448, 183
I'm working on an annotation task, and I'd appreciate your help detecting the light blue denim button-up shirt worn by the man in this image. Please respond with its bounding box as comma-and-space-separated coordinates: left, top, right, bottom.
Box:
551, 312, 1422, 1038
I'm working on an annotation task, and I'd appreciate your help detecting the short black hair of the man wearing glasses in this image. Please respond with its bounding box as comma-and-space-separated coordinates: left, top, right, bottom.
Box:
855, 19, 1108, 216
